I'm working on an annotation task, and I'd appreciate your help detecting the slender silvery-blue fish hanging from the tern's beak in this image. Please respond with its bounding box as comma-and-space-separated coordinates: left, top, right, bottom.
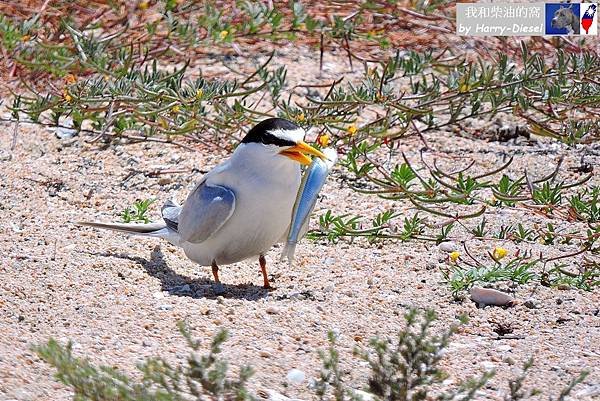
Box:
281, 148, 337, 266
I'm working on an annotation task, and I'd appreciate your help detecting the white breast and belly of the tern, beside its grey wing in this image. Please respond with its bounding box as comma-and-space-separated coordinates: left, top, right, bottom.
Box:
181, 145, 301, 265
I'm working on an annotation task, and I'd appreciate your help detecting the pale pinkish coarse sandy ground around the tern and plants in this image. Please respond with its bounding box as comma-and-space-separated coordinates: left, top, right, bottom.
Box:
0, 46, 600, 400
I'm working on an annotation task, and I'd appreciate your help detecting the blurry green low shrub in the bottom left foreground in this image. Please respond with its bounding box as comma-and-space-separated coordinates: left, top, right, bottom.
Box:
35, 324, 255, 401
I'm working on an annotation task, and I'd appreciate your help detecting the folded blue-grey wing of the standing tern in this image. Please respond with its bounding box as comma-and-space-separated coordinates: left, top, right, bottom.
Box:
177, 182, 235, 244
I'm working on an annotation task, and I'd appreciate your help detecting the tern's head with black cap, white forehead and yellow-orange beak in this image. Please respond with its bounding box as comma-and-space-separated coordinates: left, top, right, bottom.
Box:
242, 118, 326, 164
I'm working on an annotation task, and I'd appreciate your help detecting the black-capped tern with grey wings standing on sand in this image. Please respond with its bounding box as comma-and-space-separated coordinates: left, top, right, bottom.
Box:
78, 118, 326, 292
